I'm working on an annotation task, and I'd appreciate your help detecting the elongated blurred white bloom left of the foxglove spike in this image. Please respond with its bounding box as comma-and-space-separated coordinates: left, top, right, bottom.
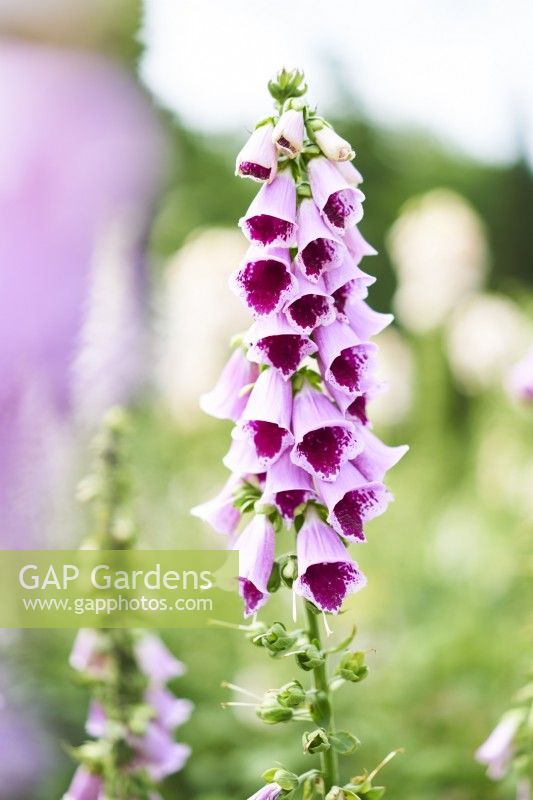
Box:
157, 228, 250, 424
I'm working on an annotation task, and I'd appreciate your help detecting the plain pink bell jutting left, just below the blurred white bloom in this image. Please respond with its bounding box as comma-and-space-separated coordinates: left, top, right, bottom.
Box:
200, 347, 259, 422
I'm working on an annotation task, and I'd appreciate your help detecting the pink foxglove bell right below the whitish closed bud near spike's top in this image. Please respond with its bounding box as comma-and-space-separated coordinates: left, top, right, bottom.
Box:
309, 157, 365, 234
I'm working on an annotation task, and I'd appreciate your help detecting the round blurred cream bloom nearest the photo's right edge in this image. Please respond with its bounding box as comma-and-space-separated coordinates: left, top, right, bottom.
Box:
446, 294, 531, 393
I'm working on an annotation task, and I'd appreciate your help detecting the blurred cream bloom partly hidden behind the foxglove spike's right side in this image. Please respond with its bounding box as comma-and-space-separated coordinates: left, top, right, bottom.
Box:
372, 328, 415, 425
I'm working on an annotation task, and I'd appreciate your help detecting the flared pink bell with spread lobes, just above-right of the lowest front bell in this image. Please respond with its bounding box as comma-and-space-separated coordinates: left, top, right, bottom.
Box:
317, 463, 392, 542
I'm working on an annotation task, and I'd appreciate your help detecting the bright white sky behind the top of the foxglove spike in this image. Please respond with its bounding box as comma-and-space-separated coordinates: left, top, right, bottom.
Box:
141, 0, 533, 161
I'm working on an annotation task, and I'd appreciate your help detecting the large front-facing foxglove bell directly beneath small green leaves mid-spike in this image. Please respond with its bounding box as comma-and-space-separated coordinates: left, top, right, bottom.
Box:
291, 386, 362, 481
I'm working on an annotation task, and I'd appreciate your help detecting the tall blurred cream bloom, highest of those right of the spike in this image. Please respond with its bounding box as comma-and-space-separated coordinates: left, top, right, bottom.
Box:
388, 189, 488, 333
